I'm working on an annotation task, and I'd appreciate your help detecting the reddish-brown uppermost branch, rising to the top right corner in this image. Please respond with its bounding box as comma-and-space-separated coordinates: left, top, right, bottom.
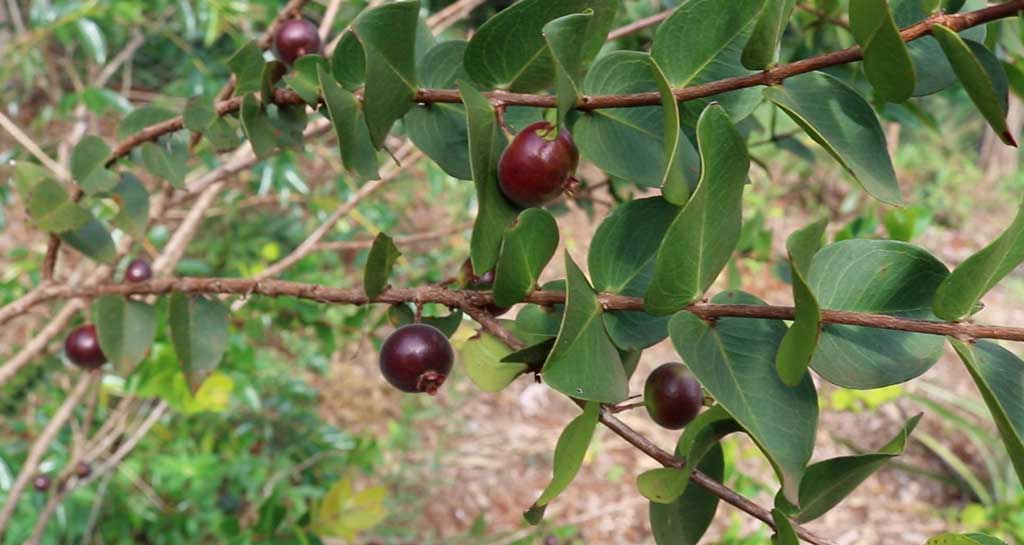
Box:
101, 0, 1024, 165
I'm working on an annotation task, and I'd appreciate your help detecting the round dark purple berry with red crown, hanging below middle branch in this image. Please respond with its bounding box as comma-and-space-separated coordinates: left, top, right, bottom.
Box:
380, 324, 455, 395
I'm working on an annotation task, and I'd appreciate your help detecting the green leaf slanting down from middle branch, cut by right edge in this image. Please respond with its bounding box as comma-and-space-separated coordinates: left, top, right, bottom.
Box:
949, 338, 1024, 484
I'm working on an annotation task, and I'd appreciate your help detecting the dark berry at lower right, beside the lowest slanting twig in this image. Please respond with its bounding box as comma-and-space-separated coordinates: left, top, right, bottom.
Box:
643, 364, 703, 429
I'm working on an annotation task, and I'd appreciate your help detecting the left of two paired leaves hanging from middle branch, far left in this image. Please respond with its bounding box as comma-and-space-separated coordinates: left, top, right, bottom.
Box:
92, 295, 157, 376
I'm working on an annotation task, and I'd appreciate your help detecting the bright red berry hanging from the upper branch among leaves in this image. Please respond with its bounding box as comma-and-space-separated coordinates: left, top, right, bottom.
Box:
498, 121, 580, 208
